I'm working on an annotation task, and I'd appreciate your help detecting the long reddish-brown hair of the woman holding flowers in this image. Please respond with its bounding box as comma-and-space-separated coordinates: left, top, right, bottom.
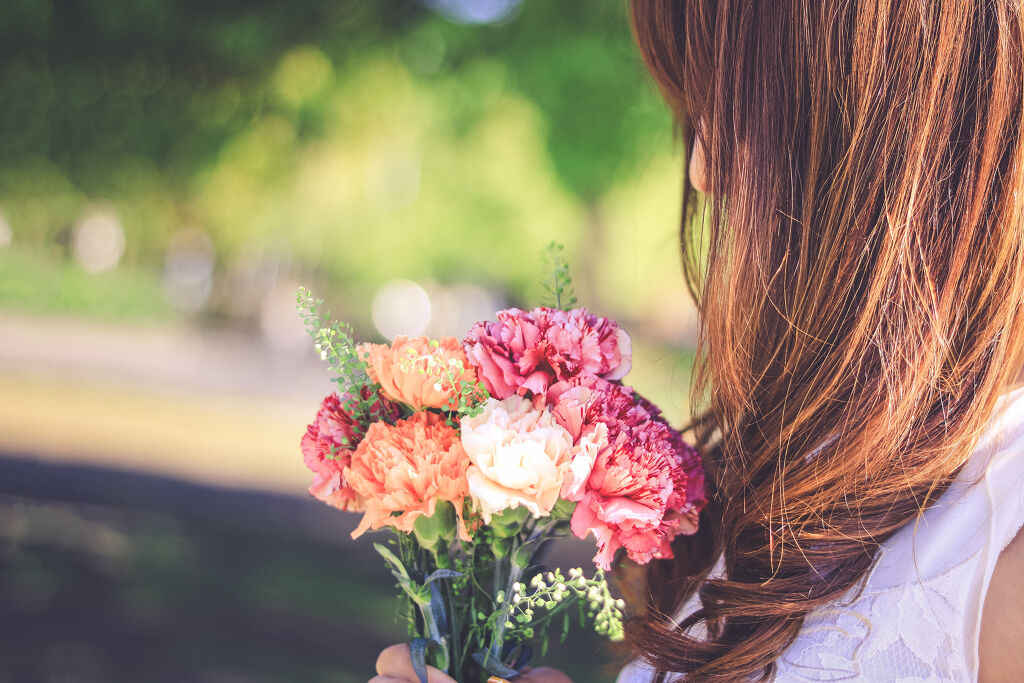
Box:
628, 0, 1024, 680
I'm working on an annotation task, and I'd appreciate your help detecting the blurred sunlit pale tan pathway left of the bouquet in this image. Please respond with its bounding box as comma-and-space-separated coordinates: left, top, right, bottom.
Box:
0, 312, 332, 494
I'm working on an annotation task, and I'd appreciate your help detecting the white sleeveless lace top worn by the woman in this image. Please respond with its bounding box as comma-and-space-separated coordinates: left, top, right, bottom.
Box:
618, 387, 1024, 683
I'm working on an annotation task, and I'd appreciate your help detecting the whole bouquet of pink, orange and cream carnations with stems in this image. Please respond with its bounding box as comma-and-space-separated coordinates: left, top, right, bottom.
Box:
298, 246, 706, 683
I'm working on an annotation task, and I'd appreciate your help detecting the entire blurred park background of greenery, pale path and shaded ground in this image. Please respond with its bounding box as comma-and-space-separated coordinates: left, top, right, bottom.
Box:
0, 0, 696, 681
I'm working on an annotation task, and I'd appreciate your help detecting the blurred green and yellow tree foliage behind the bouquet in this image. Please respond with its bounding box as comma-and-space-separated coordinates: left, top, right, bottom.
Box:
0, 0, 677, 323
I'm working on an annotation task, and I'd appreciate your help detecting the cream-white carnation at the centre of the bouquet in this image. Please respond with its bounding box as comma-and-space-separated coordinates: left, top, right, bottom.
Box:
461, 395, 573, 523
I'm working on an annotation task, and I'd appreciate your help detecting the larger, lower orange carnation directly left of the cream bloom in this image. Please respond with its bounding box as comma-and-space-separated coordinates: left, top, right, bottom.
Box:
344, 411, 469, 541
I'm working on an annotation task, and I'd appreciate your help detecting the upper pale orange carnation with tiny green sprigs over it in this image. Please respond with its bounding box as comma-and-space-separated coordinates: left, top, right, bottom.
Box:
358, 335, 476, 410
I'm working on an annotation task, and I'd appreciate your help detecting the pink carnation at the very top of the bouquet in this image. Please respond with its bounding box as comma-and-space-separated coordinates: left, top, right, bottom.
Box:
464, 308, 632, 399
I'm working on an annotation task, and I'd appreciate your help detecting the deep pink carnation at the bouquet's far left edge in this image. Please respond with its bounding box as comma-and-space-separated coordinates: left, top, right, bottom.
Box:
301, 387, 398, 511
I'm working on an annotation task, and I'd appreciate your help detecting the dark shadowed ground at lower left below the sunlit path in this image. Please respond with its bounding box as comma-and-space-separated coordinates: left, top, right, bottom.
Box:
0, 457, 613, 683
